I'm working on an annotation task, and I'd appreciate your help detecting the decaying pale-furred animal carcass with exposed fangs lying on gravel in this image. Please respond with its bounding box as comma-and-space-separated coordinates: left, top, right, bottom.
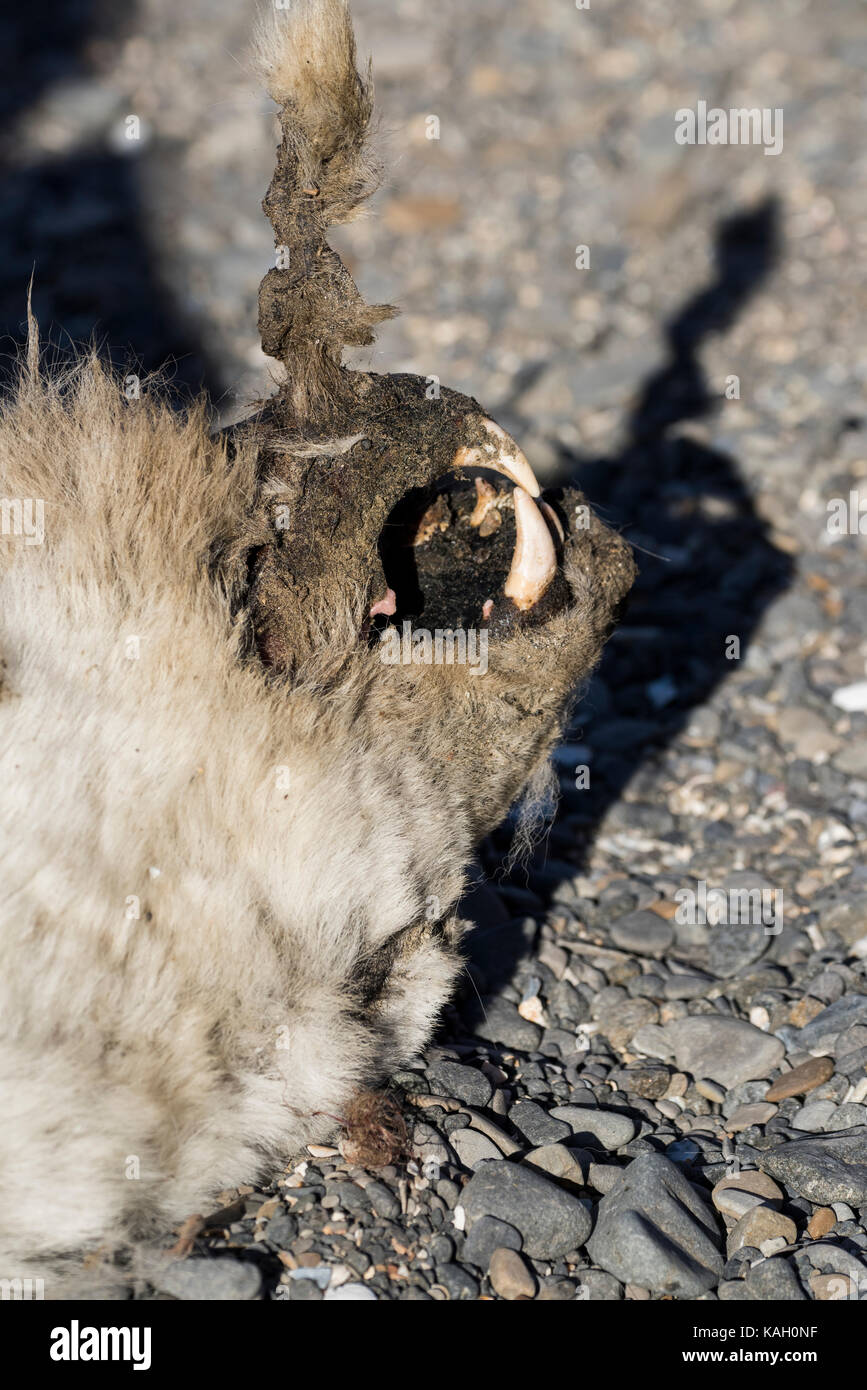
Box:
0, 0, 634, 1295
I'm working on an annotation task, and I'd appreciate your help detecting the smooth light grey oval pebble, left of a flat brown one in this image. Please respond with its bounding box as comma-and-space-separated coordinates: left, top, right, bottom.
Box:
663, 1013, 785, 1090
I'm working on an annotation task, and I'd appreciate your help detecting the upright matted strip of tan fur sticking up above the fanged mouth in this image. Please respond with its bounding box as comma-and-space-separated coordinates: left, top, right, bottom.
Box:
256, 0, 396, 427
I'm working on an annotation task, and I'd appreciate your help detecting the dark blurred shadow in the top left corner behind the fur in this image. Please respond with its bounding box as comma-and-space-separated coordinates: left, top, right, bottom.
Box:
0, 0, 217, 399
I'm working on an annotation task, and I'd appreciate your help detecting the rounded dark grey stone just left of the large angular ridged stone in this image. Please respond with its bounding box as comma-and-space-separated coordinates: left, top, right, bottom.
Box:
461, 1161, 592, 1259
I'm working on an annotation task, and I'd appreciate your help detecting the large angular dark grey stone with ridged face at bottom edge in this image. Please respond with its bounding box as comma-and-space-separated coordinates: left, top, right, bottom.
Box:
588, 1154, 723, 1298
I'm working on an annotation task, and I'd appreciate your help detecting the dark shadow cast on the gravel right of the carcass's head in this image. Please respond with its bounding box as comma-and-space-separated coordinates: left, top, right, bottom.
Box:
453, 200, 792, 1031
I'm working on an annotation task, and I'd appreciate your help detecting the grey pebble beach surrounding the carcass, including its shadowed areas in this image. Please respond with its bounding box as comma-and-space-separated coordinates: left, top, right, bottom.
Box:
6, 0, 867, 1301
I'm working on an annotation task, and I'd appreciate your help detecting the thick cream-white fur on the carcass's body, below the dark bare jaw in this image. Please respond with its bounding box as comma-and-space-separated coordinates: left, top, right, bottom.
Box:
0, 350, 470, 1294
